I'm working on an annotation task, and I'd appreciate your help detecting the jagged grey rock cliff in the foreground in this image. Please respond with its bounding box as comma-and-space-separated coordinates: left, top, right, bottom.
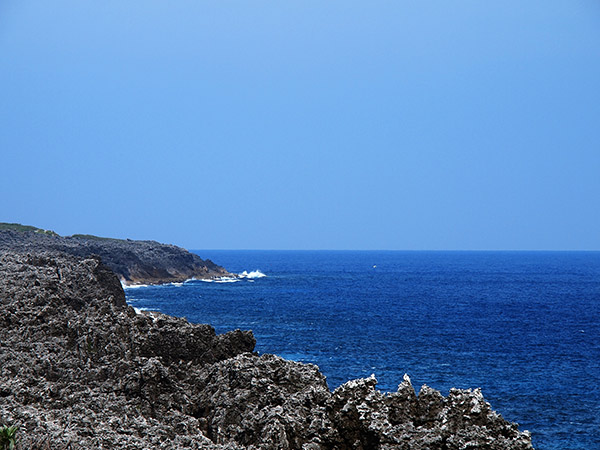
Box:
0, 252, 531, 450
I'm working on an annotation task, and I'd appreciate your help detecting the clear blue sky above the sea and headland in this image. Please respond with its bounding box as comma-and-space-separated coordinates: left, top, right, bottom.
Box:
0, 0, 600, 250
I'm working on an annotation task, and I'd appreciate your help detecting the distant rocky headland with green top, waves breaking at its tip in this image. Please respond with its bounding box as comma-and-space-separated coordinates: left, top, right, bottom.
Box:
0, 228, 229, 284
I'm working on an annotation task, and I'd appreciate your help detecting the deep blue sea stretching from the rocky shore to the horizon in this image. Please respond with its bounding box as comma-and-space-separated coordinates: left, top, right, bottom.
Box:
126, 250, 600, 450
